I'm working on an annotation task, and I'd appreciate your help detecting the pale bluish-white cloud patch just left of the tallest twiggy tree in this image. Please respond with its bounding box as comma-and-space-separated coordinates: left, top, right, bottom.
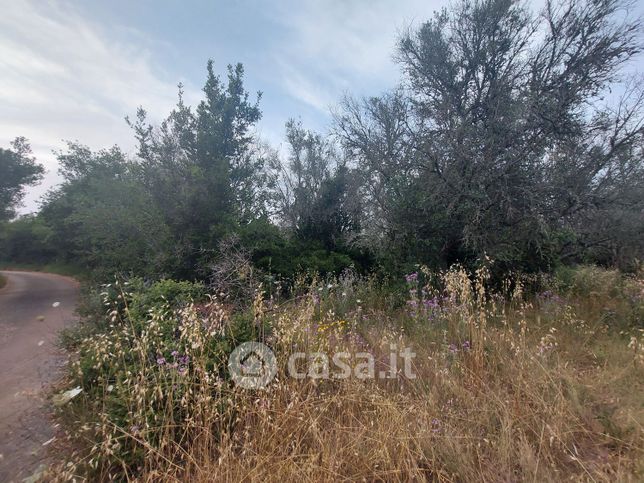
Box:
273, 0, 447, 111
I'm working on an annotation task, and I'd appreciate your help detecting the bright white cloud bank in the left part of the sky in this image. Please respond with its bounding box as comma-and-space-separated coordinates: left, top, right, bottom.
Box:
0, 1, 195, 212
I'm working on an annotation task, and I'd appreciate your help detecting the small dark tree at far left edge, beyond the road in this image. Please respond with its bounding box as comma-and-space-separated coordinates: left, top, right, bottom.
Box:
0, 137, 45, 222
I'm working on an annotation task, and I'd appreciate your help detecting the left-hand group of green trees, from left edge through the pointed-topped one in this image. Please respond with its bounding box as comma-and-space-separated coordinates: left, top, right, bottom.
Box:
0, 62, 265, 281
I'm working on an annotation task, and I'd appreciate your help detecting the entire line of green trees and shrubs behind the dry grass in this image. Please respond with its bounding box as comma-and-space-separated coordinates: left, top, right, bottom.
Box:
6, 0, 644, 290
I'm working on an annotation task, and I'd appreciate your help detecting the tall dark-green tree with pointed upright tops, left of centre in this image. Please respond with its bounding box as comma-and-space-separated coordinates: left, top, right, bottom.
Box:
128, 61, 264, 276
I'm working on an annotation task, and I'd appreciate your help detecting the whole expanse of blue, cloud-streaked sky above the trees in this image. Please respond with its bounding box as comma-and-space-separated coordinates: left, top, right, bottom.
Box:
0, 0, 641, 213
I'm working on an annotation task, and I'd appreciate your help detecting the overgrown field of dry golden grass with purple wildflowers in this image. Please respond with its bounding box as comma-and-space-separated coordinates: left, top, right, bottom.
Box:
50, 267, 644, 481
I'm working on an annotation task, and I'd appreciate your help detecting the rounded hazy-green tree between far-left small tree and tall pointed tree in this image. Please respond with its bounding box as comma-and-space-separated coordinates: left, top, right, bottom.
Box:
40, 143, 175, 279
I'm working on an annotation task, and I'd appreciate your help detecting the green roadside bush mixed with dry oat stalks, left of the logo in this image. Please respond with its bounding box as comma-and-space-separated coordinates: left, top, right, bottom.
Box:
72, 279, 257, 467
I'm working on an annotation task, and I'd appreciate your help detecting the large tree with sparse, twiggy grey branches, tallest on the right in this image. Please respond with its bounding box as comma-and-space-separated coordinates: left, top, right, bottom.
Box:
336, 0, 642, 270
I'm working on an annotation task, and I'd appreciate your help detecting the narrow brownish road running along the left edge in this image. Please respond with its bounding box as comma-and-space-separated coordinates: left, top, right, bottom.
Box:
0, 272, 78, 482
